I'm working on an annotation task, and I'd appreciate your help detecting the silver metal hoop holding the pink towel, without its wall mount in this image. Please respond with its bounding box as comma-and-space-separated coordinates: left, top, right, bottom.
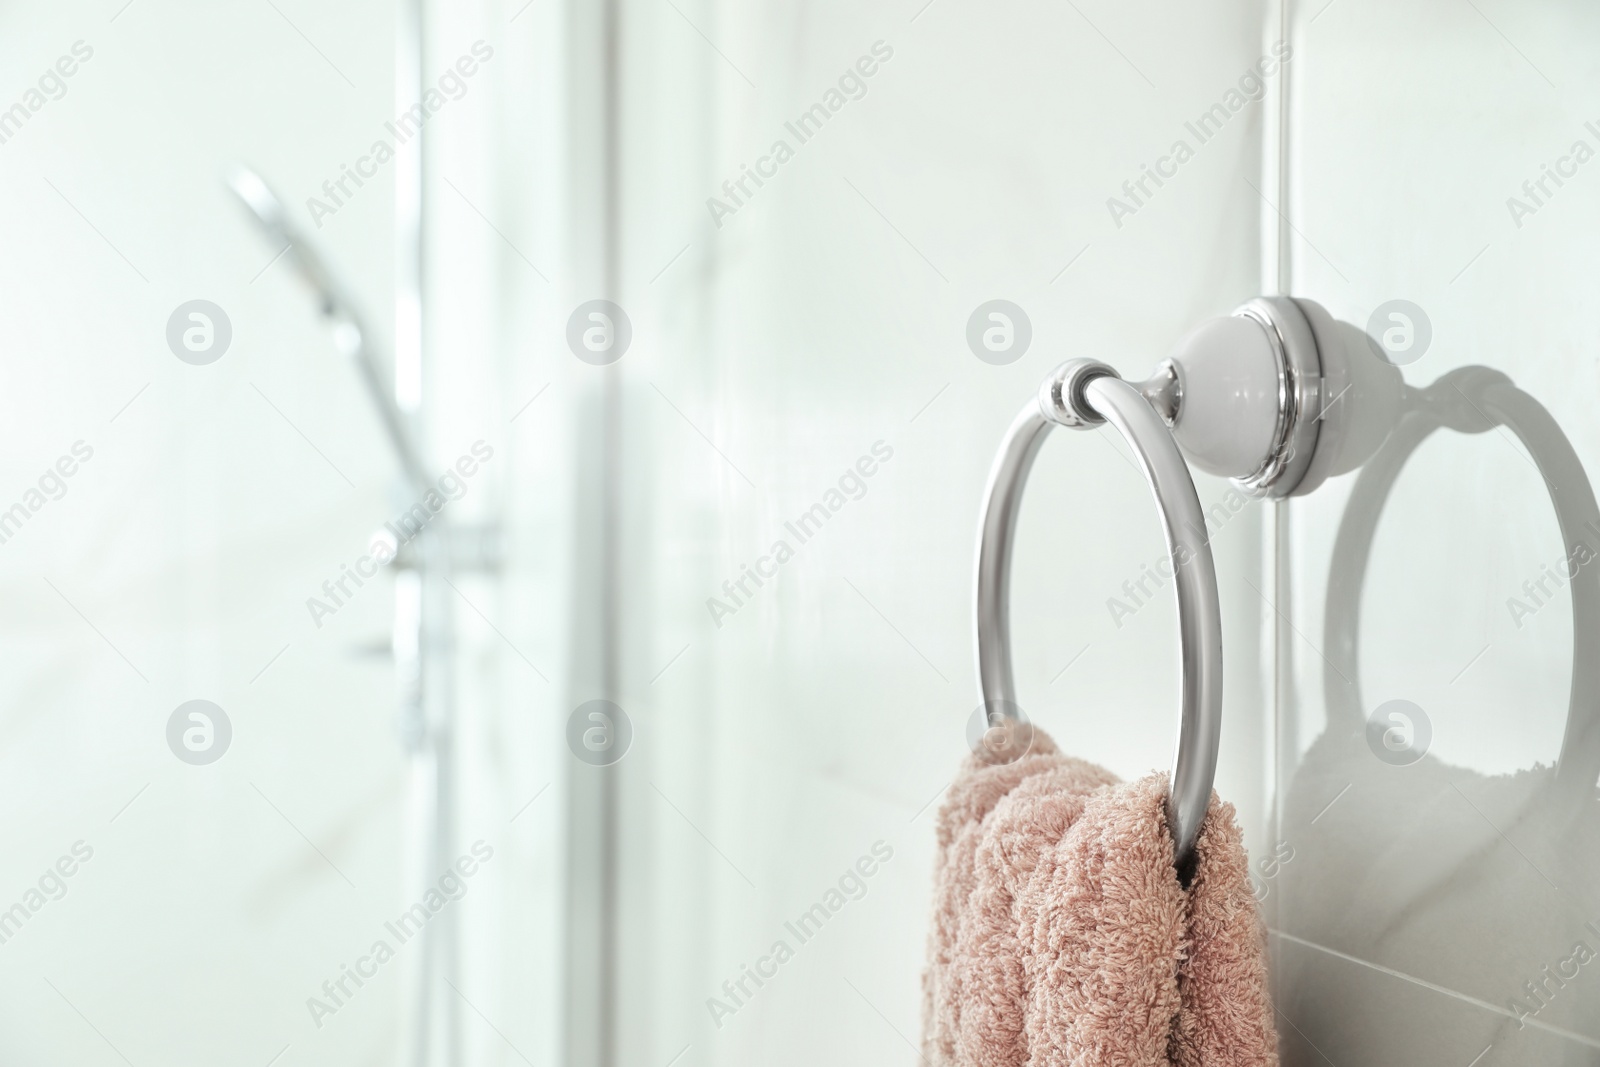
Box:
976, 360, 1222, 885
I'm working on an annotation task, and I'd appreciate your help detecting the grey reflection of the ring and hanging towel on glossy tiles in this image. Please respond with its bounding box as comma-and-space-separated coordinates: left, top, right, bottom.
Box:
1269, 366, 1600, 1065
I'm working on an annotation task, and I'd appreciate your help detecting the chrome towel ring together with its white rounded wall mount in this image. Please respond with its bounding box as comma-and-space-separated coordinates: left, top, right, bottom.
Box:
976, 296, 1420, 883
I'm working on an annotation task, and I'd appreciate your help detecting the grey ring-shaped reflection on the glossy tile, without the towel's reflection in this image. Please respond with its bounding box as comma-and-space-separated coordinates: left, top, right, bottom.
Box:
1323, 366, 1600, 811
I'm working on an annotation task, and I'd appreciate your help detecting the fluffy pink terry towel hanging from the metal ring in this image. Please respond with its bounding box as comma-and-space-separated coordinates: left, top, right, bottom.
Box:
923, 728, 1278, 1067
